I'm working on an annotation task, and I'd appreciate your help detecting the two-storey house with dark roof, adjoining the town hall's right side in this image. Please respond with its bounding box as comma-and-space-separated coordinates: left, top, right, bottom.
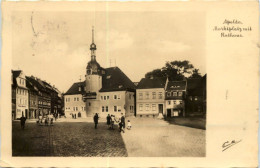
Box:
136, 78, 168, 117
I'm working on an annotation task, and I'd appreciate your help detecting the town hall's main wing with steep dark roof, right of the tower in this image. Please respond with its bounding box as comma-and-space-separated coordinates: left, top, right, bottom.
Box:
98, 67, 135, 117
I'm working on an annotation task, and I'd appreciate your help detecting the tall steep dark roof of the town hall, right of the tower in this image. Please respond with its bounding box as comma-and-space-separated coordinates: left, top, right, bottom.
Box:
100, 67, 136, 92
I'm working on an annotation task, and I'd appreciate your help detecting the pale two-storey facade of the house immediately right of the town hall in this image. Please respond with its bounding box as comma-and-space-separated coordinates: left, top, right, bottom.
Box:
136, 88, 166, 116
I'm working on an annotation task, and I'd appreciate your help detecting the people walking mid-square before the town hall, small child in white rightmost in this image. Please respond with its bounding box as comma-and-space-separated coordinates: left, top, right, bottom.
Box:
93, 113, 132, 133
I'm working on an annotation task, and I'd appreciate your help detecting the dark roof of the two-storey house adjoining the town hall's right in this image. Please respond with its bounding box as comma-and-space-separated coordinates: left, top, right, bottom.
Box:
137, 77, 167, 89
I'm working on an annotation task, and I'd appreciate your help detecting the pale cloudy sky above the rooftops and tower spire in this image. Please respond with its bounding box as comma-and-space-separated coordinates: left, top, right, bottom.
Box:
12, 11, 206, 92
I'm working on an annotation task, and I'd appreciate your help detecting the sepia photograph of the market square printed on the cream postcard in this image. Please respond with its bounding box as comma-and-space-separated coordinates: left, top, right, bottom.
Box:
12, 11, 207, 157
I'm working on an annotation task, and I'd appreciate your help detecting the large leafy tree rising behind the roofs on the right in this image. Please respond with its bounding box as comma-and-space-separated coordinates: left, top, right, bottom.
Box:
145, 60, 201, 80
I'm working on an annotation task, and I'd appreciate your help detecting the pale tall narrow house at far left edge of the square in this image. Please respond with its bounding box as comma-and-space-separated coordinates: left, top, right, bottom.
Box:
12, 70, 29, 119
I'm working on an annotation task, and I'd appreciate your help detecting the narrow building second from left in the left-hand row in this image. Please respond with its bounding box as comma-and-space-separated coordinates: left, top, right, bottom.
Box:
26, 76, 38, 119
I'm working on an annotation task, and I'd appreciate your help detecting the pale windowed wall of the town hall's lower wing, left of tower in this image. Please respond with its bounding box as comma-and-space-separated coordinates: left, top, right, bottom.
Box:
64, 94, 87, 118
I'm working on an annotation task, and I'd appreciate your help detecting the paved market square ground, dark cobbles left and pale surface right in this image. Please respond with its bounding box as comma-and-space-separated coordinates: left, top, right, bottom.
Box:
13, 118, 205, 157
